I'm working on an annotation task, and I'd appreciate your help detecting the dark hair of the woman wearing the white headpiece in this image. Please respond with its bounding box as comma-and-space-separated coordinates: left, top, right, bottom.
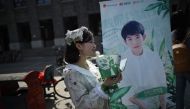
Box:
64, 29, 93, 64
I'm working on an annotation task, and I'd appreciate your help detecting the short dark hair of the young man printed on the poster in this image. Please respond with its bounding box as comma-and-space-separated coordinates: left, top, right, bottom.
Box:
121, 21, 144, 40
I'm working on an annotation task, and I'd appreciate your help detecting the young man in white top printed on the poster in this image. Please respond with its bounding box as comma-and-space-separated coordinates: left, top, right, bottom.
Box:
119, 21, 167, 109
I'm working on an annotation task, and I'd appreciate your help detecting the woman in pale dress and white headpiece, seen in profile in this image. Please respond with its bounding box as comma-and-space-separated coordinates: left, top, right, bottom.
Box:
64, 27, 121, 109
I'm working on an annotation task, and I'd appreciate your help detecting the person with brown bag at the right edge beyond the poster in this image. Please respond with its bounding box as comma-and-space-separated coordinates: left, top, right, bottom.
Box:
171, 10, 190, 109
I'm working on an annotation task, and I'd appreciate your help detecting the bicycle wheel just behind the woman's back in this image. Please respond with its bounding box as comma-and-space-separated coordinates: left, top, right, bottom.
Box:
54, 78, 71, 99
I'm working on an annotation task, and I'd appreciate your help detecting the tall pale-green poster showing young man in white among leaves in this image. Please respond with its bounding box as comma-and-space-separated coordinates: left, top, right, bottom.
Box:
100, 0, 176, 109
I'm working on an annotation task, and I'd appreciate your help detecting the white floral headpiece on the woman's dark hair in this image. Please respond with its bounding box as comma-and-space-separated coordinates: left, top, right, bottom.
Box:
65, 26, 88, 45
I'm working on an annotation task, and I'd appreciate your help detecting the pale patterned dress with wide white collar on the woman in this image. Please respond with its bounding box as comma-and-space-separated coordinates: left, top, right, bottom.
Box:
63, 61, 109, 109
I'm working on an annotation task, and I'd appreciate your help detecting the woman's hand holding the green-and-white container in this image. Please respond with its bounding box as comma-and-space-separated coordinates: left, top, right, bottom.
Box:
103, 73, 122, 86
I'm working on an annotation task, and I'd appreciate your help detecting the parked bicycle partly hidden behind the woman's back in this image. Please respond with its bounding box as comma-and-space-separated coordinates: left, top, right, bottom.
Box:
53, 65, 71, 99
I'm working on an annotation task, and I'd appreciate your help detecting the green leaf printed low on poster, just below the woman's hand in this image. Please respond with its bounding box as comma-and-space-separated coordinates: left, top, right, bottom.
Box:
110, 86, 131, 102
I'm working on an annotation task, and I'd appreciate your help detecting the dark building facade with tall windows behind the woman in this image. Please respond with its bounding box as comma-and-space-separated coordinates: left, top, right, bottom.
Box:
0, 0, 100, 50
